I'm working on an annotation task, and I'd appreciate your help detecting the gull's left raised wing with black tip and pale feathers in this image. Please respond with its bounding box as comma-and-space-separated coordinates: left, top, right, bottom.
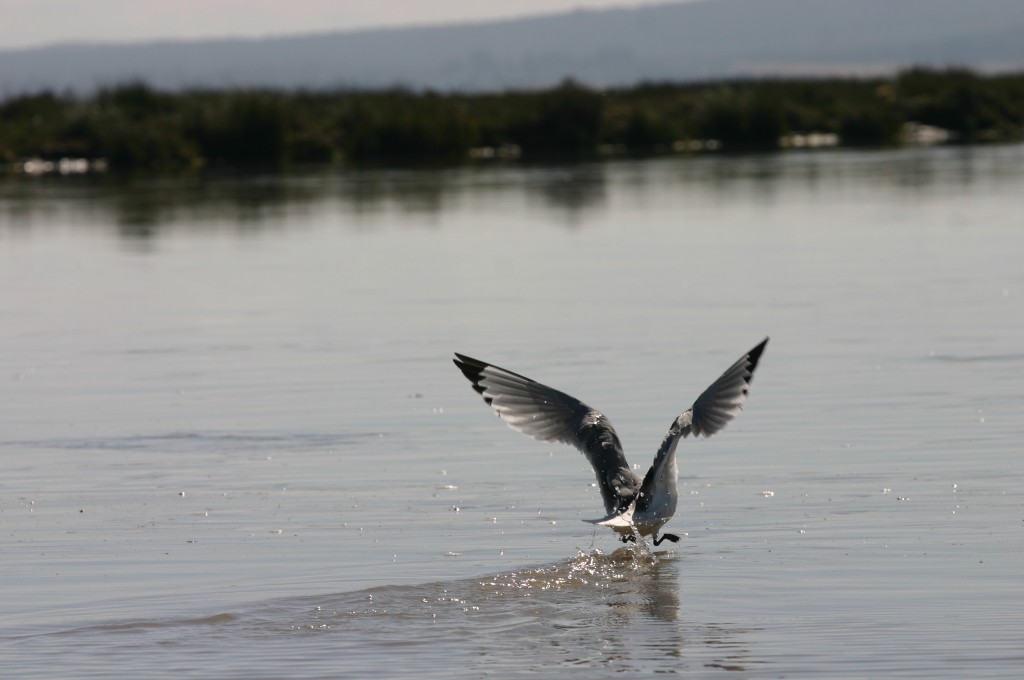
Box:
454, 353, 640, 513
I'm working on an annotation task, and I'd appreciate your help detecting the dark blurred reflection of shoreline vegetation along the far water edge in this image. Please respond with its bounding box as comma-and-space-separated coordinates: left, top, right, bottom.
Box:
0, 147, 991, 240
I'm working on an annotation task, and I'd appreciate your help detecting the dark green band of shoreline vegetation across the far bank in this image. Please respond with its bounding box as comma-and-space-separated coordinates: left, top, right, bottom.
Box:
0, 69, 1024, 169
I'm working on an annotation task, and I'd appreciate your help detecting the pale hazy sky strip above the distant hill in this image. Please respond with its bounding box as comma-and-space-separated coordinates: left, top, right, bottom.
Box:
0, 0, 688, 49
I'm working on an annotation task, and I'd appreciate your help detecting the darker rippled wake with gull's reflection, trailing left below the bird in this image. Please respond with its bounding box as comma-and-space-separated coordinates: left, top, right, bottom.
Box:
20, 547, 757, 677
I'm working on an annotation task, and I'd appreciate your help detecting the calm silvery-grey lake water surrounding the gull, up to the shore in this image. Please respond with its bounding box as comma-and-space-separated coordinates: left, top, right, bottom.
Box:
0, 146, 1024, 678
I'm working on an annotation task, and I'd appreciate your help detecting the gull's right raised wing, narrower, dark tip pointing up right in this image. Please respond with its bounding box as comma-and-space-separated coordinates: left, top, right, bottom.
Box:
638, 338, 768, 509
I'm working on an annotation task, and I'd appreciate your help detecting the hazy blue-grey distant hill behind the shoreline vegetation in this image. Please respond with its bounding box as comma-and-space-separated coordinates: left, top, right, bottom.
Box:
0, 0, 1024, 96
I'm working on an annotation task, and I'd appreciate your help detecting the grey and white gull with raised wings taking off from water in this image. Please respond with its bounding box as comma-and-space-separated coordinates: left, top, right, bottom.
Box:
454, 338, 768, 546
